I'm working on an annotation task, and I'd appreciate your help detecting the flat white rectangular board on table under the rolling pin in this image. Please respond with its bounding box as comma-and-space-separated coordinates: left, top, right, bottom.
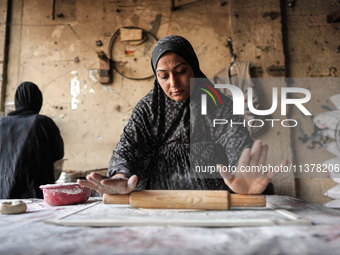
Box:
46, 202, 311, 227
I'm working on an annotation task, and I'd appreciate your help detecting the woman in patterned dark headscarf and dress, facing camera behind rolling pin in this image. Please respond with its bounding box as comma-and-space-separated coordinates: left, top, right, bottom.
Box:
78, 35, 287, 194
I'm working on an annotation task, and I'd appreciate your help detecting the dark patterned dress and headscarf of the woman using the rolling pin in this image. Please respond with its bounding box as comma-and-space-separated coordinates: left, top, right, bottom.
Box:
109, 36, 253, 190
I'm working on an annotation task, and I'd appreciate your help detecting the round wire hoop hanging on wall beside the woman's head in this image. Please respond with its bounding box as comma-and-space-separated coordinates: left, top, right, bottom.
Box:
108, 26, 157, 80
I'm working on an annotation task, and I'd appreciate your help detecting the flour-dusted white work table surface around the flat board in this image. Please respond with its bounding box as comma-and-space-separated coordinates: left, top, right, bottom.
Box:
0, 196, 340, 255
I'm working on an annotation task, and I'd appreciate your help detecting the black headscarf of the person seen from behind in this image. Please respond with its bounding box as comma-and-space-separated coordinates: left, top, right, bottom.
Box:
15, 81, 43, 113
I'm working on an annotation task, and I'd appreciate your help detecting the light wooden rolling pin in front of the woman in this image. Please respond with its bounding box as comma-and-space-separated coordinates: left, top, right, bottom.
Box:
103, 190, 266, 210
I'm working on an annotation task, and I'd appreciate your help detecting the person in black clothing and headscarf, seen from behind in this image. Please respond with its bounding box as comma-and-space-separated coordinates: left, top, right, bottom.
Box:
0, 82, 64, 199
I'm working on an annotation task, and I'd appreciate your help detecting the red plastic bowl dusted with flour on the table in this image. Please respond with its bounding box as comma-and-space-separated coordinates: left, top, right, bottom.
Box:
39, 182, 91, 205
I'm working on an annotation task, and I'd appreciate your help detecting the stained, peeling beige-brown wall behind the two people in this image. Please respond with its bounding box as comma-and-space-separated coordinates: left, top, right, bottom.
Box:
0, 0, 340, 203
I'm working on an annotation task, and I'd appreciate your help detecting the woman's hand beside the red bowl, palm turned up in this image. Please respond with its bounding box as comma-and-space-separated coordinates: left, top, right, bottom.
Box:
77, 173, 138, 194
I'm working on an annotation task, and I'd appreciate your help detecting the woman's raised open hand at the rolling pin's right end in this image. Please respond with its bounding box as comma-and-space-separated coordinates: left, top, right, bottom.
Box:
220, 140, 288, 194
